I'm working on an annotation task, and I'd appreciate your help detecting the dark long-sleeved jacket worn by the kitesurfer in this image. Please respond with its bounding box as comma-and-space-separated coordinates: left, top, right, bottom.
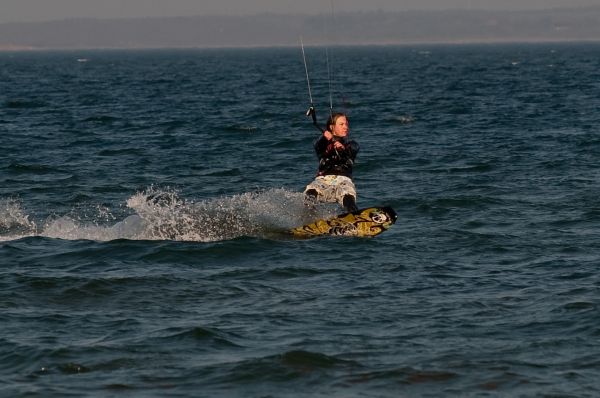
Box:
314, 135, 359, 178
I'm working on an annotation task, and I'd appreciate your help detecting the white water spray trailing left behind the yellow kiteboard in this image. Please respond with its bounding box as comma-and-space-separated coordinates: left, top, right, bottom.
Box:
0, 188, 337, 242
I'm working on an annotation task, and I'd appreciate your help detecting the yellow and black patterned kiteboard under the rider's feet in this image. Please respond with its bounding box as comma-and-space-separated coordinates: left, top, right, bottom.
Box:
291, 207, 397, 238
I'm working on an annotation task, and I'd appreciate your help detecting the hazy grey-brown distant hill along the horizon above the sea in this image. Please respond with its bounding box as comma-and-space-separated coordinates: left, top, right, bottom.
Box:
0, 7, 600, 50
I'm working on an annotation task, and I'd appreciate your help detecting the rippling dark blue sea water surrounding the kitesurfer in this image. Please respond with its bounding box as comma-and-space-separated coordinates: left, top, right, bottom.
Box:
0, 43, 600, 397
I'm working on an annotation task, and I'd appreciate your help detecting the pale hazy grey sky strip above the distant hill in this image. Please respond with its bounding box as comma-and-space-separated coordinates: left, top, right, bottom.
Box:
0, 0, 600, 23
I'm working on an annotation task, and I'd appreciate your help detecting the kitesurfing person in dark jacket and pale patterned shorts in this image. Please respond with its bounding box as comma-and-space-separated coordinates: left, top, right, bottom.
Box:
304, 113, 359, 212
